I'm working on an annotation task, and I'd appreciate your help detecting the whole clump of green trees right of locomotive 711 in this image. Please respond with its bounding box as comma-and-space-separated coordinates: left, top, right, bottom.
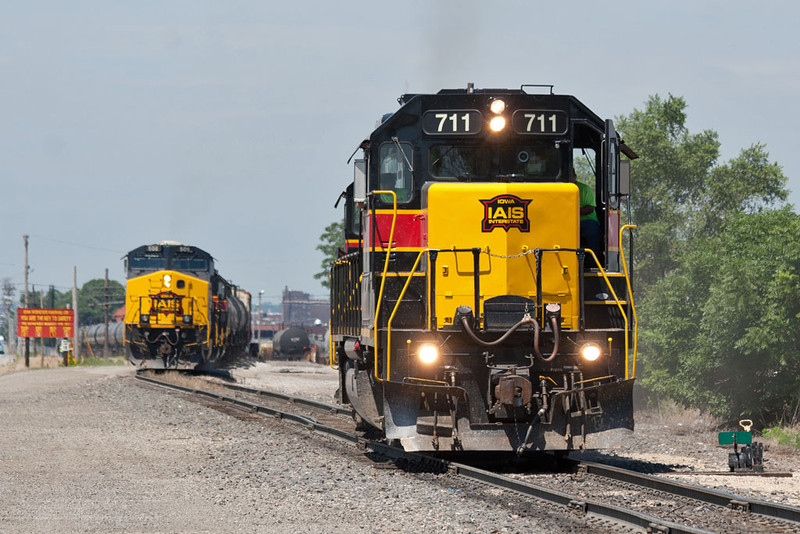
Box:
617, 95, 800, 421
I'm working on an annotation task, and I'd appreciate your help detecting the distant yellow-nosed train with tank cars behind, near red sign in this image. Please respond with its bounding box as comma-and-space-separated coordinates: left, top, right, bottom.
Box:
124, 245, 250, 369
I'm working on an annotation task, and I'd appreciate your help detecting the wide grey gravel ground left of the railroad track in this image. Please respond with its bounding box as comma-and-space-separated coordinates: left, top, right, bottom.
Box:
0, 364, 620, 533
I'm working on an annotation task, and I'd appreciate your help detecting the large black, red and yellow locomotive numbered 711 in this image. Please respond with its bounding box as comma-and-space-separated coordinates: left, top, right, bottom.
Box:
330, 85, 636, 454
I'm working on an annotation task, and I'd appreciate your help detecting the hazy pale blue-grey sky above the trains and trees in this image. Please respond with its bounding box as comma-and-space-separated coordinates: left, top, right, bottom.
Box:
0, 0, 800, 301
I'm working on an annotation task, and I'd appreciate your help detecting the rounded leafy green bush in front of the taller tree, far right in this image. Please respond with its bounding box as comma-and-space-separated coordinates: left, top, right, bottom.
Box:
640, 208, 800, 423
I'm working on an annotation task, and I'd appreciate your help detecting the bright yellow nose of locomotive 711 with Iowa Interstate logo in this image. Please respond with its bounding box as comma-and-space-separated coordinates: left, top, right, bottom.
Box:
423, 182, 580, 330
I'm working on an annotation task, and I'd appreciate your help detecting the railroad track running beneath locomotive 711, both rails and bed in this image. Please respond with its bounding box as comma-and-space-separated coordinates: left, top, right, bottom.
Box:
137, 373, 800, 534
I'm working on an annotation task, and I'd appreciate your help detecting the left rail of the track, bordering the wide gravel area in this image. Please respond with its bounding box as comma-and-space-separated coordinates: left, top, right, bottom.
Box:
131, 373, 713, 534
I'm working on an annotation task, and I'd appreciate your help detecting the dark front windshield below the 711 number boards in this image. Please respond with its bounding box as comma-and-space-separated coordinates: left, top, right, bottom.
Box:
429, 144, 560, 181
